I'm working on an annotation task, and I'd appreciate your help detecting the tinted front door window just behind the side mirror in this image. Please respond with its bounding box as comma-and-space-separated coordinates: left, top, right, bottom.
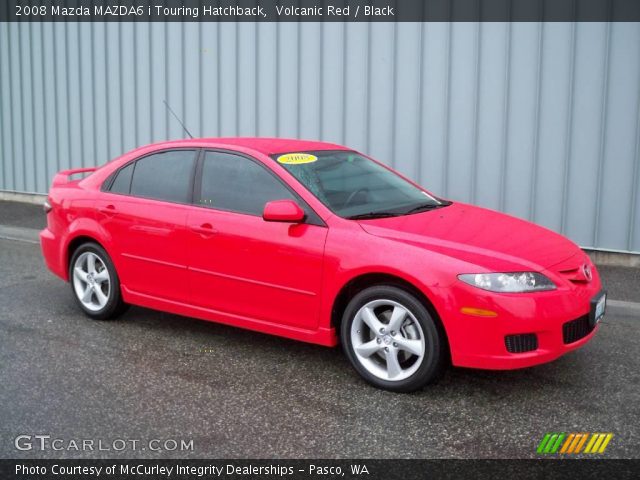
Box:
199, 152, 295, 215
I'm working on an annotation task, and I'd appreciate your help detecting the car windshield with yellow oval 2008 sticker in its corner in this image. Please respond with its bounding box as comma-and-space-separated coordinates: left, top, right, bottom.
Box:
273, 151, 450, 219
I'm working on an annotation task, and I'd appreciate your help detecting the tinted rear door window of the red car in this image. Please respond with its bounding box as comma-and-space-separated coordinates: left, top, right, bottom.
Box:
131, 150, 196, 203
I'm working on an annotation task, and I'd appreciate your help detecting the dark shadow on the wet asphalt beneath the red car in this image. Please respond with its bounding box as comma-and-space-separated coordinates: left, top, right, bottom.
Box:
116, 307, 592, 397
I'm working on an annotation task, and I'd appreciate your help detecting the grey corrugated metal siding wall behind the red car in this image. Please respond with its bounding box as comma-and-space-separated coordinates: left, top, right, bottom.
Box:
0, 23, 640, 252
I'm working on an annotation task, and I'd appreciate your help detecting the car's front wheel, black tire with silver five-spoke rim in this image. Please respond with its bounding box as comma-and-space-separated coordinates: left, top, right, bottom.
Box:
341, 286, 446, 392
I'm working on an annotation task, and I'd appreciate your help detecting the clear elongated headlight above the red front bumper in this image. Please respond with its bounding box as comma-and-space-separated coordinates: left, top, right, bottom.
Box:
458, 272, 556, 293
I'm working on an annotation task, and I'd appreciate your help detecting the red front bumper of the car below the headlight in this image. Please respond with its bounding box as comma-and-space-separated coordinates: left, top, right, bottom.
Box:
436, 270, 601, 370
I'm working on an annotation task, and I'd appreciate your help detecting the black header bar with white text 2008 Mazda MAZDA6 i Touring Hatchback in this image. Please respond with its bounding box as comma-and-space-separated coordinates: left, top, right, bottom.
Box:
0, 0, 640, 22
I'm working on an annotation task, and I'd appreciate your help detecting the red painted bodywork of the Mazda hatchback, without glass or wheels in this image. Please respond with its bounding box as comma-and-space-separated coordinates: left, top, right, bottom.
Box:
40, 138, 601, 369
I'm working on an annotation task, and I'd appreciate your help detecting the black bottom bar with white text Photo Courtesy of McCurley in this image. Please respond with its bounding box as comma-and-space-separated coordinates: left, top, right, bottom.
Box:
0, 459, 640, 480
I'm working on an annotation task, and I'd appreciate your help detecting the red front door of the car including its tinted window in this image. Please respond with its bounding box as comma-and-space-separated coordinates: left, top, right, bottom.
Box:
187, 151, 327, 330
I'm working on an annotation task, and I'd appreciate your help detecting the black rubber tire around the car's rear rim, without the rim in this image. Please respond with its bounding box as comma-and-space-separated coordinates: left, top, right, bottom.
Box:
69, 242, 129, 320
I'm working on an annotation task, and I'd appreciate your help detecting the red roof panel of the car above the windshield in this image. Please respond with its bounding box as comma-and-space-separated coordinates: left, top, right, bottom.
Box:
146, 137, 349, 155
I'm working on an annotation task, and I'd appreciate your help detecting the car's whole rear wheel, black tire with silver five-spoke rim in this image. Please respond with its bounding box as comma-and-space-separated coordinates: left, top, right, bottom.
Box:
69, 242, 127, 320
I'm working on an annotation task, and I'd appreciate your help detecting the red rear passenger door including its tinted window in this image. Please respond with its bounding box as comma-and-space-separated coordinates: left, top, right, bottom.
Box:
98, 149, 198, 302
